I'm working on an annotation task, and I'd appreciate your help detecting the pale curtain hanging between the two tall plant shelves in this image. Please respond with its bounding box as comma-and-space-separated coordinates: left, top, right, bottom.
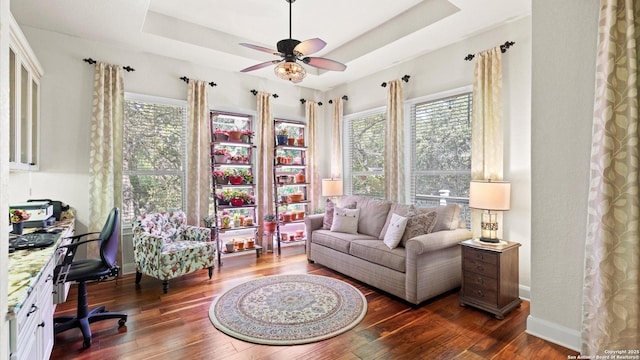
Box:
256, 92, 275, 249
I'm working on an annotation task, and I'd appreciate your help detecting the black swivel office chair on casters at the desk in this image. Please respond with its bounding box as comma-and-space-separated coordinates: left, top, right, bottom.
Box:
53, 208, 127, 349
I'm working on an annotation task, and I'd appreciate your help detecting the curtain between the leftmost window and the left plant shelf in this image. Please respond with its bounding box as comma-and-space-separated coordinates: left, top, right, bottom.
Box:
185, 80, 211, 226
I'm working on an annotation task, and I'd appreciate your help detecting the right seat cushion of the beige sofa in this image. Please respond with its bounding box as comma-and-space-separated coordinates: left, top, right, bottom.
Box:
349, 239, 407, 273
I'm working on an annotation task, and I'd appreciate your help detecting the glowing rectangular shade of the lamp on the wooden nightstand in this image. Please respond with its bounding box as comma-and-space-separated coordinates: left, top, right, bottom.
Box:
469, 180, 511, 211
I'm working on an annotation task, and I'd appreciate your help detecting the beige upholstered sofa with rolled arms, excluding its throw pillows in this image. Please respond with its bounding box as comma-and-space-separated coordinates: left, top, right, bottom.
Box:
305, 196, 472, 304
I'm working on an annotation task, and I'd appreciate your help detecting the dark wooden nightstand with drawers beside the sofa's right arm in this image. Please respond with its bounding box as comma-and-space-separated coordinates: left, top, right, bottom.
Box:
460, 240, 522, 320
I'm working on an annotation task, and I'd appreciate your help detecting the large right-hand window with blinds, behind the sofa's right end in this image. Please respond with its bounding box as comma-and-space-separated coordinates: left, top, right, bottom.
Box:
409, 88, 472, 222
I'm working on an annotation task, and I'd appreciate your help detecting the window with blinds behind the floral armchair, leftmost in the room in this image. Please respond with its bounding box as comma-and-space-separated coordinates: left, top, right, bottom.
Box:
122, 93, 187, 224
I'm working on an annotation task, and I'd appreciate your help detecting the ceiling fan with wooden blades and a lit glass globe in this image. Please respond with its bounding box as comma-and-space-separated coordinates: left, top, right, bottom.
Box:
240, 0, 347, 83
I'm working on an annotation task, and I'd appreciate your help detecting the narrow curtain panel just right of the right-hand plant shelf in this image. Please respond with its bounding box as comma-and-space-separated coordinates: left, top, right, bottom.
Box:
305, 101, 322, 210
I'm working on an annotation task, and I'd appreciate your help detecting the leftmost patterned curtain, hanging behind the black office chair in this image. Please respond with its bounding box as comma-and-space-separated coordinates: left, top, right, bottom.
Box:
87, 62, 124, 258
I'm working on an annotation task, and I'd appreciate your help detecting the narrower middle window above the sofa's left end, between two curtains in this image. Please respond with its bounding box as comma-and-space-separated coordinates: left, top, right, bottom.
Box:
343, 109, 387, 198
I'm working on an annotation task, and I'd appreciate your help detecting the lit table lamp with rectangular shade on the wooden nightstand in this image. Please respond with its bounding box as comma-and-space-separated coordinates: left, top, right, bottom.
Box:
469, 180, 511, 243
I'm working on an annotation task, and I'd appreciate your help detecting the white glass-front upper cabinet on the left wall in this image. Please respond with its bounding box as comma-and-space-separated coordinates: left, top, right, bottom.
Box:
9, 16, 43, 170
